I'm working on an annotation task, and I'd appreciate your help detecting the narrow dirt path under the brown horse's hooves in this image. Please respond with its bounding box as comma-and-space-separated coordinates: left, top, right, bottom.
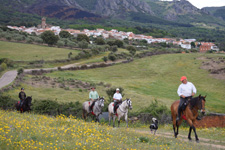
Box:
134, 130, 225, 149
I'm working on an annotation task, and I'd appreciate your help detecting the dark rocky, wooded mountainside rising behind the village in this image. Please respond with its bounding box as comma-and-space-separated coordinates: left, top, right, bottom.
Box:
0, 0, 225, 41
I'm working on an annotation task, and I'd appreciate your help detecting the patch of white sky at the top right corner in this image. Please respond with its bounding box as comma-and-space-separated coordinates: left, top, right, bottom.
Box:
162, 0, 225, 9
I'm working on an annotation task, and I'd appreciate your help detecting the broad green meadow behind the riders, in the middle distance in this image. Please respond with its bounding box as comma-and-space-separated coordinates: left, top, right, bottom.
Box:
3, 53, 225, 113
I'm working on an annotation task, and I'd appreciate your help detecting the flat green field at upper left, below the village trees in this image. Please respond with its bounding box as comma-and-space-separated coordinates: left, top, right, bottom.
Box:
0, 41, 79, 61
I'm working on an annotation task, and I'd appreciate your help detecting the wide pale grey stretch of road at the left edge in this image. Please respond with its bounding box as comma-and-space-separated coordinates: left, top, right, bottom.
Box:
0, 70, 17, 89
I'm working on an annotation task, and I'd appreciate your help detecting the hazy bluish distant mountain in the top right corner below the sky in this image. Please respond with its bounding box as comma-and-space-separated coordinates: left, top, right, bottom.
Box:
202, 6, 225, 20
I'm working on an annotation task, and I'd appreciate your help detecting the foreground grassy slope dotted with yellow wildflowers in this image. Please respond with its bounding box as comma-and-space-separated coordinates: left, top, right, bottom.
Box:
0, 110, 224, 150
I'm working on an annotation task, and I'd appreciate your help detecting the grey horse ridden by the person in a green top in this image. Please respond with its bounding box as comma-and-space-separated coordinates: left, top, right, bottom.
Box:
82, 97, 105, 122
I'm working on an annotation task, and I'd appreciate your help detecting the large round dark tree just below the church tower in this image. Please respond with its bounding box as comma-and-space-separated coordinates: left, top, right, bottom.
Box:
41, 31, 59, 46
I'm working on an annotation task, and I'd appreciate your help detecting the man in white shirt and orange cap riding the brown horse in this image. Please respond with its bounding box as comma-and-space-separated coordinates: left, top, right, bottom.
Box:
176, 76, 197, 121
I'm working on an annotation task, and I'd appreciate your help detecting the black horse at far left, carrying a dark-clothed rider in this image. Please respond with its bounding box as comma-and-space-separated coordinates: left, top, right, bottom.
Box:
15, 96, 32, 113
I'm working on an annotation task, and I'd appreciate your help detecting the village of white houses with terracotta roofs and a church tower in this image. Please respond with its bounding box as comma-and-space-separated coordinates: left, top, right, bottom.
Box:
7, 17, 219, 52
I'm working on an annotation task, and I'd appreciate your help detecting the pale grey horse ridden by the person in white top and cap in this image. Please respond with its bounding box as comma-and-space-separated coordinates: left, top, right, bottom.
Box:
108, 98, 132, 127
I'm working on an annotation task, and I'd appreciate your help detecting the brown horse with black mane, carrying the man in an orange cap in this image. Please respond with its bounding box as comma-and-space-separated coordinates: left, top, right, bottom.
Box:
171, 95, 206, 143
